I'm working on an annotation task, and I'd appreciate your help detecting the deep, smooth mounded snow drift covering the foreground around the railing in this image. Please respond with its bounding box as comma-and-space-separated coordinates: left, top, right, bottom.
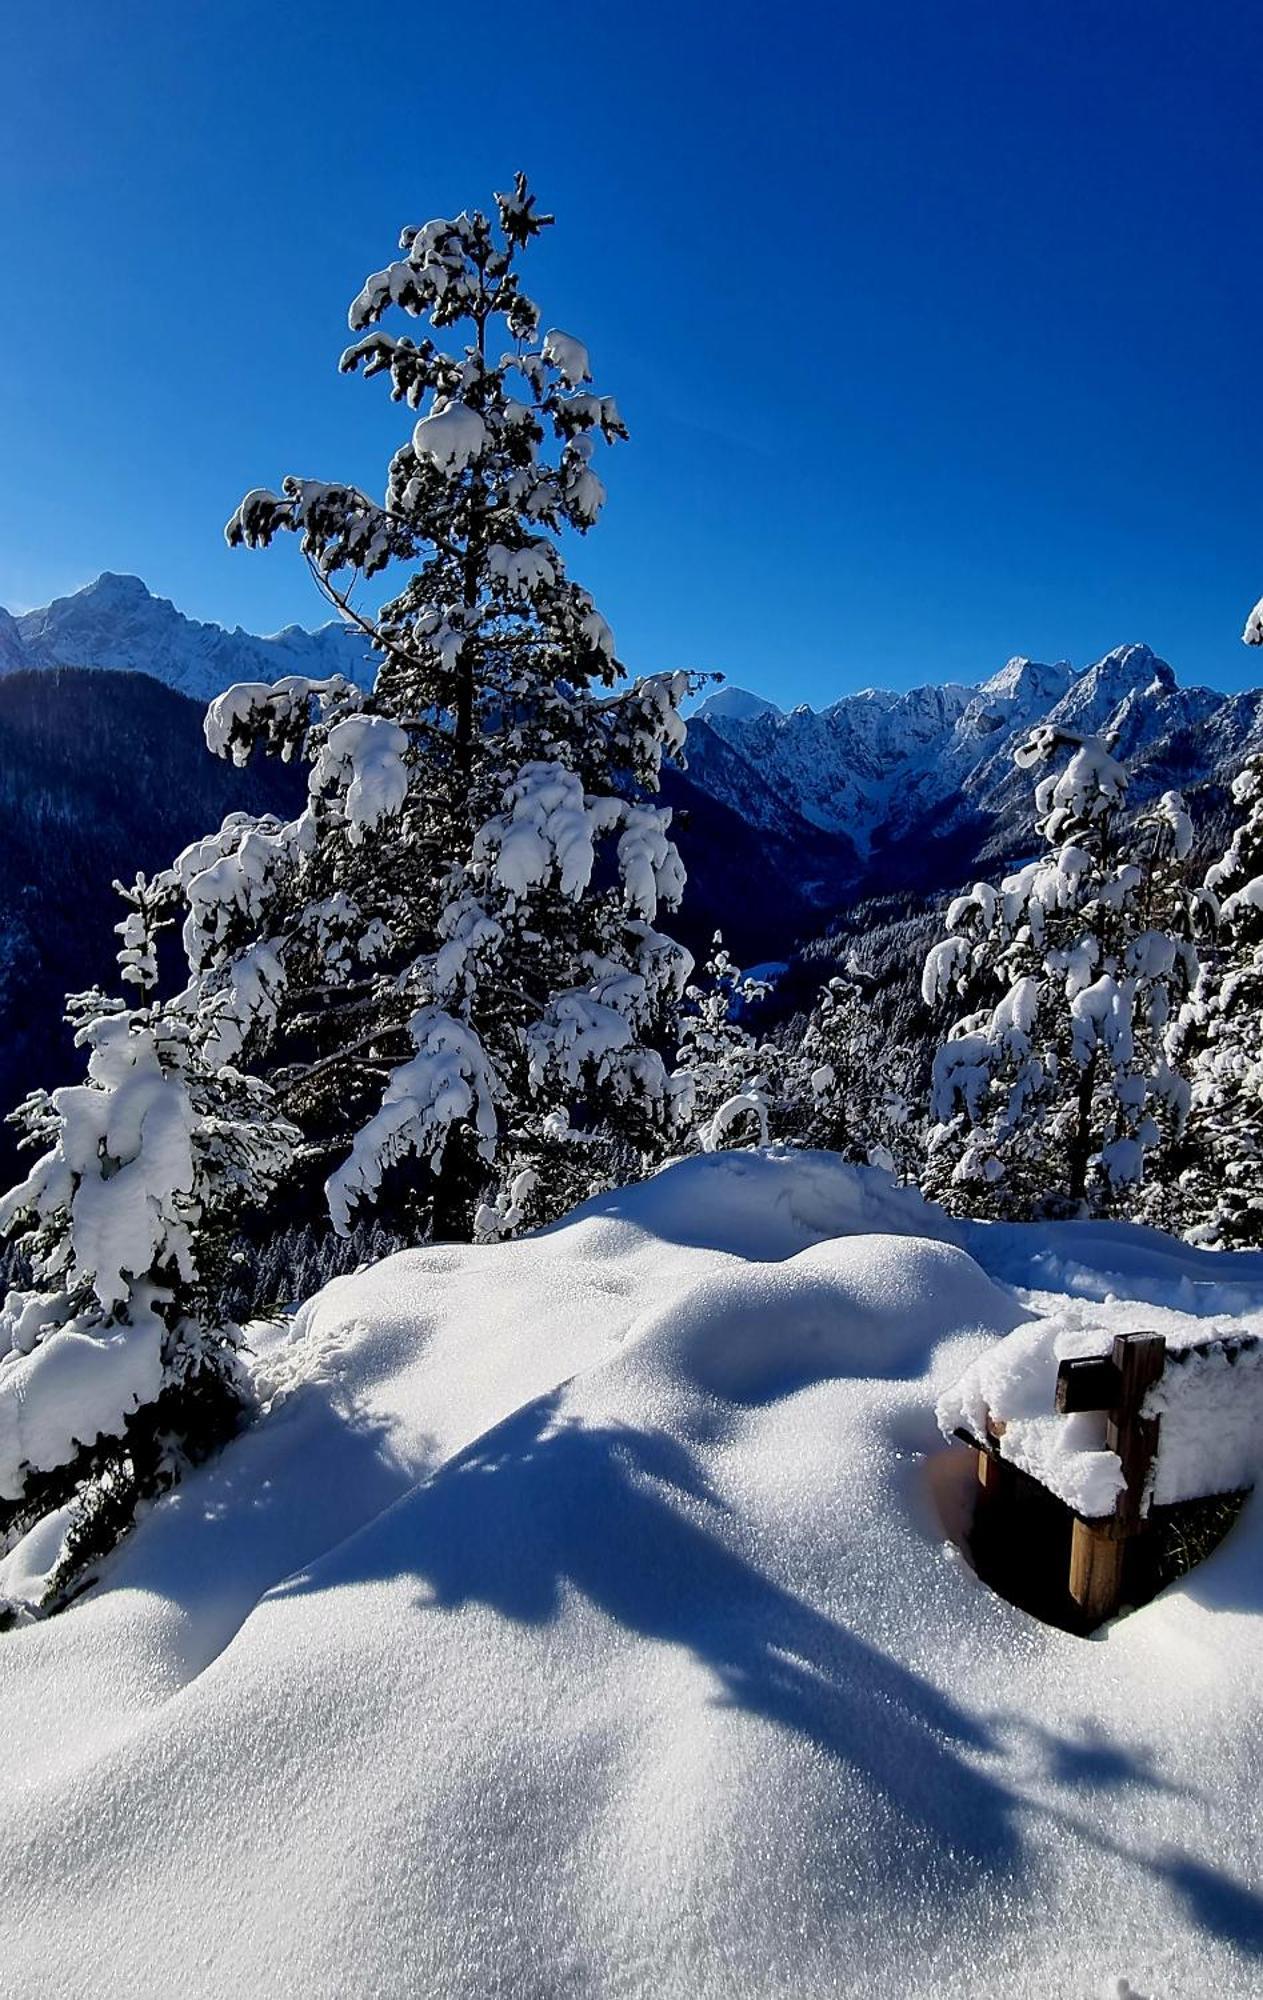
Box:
0, 1154, 1263, 2000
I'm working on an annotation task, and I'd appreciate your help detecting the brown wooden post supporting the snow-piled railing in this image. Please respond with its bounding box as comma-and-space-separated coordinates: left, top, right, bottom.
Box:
1057, 1334, 1167, 1624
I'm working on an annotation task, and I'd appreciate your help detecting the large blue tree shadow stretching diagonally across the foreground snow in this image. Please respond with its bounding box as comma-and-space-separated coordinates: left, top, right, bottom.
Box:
282, 1392, 1021, 1894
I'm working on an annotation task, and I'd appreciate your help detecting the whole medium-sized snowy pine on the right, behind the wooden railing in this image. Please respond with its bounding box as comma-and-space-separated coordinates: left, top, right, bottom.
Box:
921, 724, 1197, 1216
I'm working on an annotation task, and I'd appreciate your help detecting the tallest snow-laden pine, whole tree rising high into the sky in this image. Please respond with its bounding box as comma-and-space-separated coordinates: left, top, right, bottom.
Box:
132, 176, 691, 1236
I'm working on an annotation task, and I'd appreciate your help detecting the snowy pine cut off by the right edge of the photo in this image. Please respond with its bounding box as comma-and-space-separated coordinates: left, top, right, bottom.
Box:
1181, 756, 1263, 1246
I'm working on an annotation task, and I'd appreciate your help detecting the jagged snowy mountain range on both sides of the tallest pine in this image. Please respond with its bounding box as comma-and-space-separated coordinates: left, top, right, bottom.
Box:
0, 574, 1263, 962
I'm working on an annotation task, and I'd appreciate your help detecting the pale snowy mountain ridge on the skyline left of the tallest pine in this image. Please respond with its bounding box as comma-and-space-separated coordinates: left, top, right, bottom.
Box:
0, 572, 372, 702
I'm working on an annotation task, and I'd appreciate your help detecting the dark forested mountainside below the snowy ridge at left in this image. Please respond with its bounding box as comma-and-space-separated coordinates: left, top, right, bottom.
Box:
0, 668, 302, 1184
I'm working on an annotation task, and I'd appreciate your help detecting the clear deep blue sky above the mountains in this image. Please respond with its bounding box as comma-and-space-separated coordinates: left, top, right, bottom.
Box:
0, 0, 1263, 702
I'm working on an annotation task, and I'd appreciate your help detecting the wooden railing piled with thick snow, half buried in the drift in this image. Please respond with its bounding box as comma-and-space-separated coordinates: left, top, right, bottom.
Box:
939, 1330, 1263, 1626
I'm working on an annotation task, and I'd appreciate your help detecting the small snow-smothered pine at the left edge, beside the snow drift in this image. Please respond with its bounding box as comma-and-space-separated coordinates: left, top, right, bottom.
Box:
0, 948, 298, 1612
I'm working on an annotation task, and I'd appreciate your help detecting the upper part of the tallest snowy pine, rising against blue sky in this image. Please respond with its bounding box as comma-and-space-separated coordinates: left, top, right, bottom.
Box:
226, 176, 628, 704
